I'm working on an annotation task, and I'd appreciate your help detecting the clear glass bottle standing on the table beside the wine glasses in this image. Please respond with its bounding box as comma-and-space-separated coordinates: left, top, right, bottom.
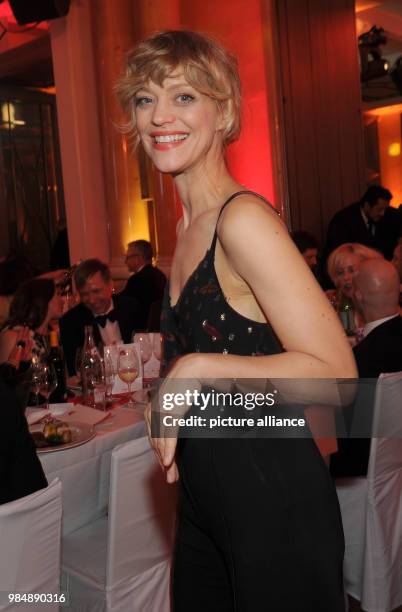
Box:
81, 325, 106, 408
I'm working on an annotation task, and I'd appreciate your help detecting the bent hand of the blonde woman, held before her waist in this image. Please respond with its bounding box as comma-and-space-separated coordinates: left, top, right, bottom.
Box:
145, 353, 204, 483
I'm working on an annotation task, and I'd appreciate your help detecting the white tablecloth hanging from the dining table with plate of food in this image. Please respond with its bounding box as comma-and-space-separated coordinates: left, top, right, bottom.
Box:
39, 407, 146, 534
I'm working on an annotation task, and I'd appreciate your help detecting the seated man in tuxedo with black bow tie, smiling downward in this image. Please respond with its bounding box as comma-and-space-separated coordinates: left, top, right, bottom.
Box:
60, 259, 145, 376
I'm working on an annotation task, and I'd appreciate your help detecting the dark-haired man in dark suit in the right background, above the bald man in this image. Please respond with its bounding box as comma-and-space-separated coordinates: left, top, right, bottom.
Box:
323, 185, 402, 260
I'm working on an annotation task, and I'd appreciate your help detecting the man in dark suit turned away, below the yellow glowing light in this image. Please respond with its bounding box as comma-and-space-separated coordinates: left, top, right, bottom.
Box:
120, 240, 166, 331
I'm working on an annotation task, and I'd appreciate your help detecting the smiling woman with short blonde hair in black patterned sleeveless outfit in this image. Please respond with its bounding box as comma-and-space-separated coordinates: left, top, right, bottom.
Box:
117, 31, 356, 612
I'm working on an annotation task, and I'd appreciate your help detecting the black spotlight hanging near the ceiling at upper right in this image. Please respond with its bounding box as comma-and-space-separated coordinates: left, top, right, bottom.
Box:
359, 26, 389, 81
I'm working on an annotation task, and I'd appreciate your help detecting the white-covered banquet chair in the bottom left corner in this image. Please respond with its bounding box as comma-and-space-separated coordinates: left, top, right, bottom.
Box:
0, 478, 62, 612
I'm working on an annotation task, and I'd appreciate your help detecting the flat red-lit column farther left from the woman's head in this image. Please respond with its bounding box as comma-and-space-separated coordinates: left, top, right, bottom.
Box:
49, 0, 110, 262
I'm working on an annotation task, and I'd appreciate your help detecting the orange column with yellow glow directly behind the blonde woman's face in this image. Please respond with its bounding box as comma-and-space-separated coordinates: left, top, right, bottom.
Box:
91, 0, 181, 278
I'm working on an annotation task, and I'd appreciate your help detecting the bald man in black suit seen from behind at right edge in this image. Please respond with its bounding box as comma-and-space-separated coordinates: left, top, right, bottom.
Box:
353, 259, 402, 378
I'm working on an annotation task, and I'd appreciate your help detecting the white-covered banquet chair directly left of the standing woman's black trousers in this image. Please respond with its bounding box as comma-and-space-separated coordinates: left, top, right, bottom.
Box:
62, 438, 176, 612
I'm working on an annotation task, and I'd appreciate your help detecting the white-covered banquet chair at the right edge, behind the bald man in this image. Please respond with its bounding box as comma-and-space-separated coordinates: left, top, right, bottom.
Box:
336, 372, 402, 612
